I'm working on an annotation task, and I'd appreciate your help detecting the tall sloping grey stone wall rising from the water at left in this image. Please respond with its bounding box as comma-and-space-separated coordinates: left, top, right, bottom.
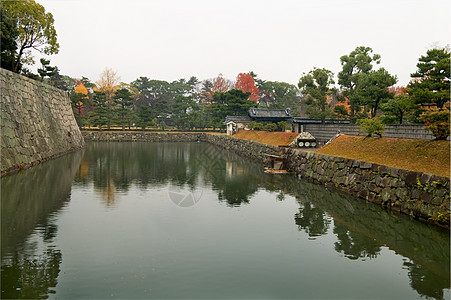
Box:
0, 69, 84, 175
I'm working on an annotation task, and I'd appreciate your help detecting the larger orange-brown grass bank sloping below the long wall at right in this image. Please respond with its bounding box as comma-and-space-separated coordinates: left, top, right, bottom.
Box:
316, 135, 450, 178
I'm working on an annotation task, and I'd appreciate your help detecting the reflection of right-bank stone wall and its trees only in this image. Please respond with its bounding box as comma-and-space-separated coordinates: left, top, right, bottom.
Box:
280, 180, 450, 299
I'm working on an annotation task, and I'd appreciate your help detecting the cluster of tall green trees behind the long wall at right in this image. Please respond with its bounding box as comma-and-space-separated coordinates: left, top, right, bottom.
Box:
298, 45, 450, 139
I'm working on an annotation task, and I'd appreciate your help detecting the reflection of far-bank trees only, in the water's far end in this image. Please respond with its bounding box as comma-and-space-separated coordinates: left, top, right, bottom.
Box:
76, 143, 260, 206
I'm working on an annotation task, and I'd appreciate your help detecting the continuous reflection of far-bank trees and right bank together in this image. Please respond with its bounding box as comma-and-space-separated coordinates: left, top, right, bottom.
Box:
73, 143, 450, 299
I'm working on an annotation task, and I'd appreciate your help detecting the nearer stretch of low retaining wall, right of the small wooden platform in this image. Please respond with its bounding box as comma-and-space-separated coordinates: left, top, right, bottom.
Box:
284, 149, 450, 226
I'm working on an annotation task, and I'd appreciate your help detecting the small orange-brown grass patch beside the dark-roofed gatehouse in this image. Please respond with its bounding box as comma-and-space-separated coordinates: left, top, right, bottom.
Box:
233, 130, 298, 146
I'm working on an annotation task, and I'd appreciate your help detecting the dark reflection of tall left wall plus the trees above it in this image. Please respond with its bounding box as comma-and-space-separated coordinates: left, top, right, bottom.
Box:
0, 152, 82, 299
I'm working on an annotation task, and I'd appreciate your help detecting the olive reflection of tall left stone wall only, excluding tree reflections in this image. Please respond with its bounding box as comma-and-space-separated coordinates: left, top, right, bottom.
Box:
0, 151, 83, 257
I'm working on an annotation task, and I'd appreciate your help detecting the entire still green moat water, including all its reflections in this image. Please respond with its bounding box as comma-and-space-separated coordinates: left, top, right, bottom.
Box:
1, 143, 450, 299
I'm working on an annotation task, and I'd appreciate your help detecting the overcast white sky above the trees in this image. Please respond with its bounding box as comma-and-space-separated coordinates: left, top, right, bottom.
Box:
36, 0, 451, 86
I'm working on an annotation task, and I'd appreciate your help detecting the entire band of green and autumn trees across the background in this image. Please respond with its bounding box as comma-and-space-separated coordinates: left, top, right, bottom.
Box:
1, 0, 450, 138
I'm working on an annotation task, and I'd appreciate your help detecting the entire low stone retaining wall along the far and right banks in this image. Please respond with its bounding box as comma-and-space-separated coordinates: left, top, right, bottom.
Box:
79, 131, 450, 228
